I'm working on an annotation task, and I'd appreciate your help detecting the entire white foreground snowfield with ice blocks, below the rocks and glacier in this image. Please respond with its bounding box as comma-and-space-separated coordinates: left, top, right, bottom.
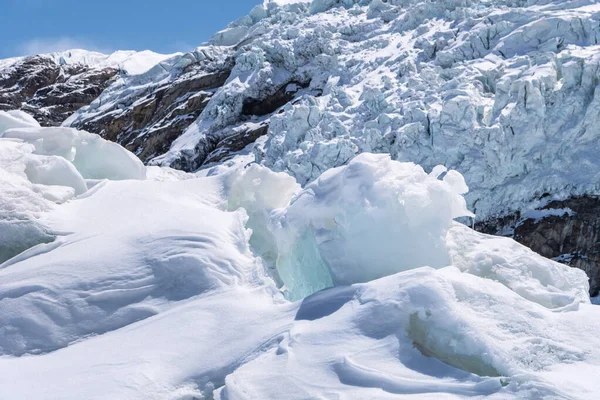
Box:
0, 112, 600, 400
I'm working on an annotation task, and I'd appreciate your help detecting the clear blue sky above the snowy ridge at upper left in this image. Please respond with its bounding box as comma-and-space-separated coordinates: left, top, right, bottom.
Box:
0, 0, 262, 58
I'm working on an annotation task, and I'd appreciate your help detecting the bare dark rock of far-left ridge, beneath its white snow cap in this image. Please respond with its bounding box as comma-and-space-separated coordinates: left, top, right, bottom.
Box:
0, 56, 119, 126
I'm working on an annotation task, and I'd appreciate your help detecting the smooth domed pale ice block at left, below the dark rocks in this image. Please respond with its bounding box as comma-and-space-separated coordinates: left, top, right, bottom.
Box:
0, 128, 146, 180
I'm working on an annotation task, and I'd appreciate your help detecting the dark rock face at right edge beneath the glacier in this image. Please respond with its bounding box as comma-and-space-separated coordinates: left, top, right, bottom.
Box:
476, 196, 600, 296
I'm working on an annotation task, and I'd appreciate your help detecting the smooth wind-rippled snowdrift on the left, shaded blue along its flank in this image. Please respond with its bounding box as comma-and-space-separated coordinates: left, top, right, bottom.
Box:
0, 179, 266, 355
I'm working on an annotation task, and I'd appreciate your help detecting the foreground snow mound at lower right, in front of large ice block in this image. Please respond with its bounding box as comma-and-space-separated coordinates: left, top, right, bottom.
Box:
216, 267, 600, 400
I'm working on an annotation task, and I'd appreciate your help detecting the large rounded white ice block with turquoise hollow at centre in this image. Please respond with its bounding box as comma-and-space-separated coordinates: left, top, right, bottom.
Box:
230, 154, 473, 299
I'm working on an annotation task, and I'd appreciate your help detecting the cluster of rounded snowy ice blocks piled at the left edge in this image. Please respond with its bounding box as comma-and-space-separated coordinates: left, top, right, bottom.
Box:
0, 111, 146, 263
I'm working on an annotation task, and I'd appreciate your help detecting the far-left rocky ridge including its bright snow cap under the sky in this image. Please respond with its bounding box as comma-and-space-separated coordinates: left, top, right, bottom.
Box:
0, 50, 175, 126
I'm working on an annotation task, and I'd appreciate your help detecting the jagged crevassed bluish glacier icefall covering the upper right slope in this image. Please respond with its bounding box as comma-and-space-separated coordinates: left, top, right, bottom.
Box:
74, 0, 600, 219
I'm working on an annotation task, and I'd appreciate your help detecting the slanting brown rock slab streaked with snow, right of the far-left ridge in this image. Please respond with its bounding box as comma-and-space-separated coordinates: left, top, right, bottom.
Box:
66, 51, 232, 162
